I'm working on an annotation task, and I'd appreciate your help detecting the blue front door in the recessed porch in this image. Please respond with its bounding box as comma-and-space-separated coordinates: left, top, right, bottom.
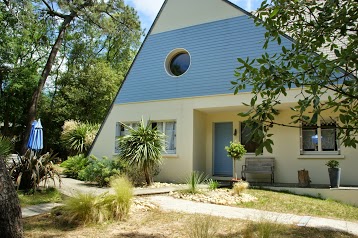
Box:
213, 122, 233, 177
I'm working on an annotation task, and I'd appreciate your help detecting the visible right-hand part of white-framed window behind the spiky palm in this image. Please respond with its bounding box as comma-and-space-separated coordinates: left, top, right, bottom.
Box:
152, 121, 176, 154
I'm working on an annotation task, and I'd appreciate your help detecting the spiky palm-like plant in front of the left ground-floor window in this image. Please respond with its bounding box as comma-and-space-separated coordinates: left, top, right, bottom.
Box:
118, 119, 165, 185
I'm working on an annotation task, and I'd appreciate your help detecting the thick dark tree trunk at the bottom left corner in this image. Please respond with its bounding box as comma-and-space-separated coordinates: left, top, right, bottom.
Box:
0, 158, 23, 238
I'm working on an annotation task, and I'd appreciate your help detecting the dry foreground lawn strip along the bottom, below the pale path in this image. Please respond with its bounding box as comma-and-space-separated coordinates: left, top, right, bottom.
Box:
24, 209, 357, 238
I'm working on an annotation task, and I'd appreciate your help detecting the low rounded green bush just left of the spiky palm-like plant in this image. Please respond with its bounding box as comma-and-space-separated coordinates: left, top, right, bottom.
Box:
78, 155, 124, 186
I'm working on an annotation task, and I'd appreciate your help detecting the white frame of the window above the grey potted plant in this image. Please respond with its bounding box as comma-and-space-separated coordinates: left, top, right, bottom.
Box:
300, 120, 341, 155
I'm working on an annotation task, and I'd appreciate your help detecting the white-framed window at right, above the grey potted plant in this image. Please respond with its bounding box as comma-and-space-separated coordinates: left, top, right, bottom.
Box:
301, 121, 339, 154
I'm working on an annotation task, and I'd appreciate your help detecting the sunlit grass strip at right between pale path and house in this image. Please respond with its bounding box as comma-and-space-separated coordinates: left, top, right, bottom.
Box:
238, 189, 358, 221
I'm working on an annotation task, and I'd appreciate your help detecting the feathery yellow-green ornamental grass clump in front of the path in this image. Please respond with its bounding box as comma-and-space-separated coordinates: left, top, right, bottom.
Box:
55, 177, 133, 224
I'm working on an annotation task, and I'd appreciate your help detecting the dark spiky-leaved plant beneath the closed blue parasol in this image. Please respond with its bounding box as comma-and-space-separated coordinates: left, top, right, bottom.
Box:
9, 150, 61, 192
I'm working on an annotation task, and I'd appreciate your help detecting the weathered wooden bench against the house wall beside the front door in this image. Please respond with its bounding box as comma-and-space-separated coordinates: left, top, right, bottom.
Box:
241, 157, 275, 183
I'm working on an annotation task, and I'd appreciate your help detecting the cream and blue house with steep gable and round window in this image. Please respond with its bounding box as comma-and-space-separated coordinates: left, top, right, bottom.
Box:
90, 0, 358, 185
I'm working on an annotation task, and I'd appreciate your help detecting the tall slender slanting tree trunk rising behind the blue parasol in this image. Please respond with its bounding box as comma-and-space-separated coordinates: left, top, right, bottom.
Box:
21, 13, 76, 154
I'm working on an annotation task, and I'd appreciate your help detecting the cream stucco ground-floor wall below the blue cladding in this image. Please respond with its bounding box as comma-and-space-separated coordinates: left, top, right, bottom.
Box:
91, 90, 358, 185
